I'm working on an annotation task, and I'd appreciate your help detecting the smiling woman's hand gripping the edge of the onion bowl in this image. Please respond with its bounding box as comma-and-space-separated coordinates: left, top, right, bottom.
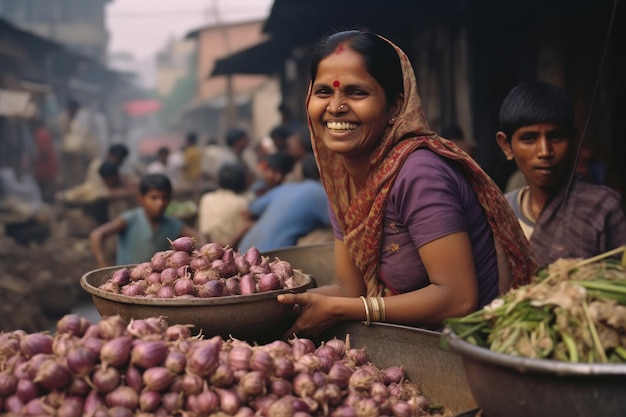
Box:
278, 292, 347, 338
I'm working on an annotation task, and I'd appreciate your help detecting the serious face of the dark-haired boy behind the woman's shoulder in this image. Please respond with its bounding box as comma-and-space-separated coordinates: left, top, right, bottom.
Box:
496, 123, 571, 190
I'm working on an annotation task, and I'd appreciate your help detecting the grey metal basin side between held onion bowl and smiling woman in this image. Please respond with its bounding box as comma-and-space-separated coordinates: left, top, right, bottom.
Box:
263, 242, 335, 286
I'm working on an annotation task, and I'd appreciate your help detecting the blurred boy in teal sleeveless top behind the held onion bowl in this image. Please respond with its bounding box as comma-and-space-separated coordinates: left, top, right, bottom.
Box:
89, 174, 205, 267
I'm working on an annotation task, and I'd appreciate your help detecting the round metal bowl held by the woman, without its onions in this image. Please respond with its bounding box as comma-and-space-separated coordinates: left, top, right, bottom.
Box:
80, 265, 311, 343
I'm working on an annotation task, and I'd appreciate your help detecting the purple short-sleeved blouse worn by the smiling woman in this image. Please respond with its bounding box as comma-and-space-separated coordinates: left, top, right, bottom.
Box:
330, 149, 498, 307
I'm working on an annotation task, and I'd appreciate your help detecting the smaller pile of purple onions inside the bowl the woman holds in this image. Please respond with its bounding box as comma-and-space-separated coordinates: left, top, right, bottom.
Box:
98, 237, 296, 298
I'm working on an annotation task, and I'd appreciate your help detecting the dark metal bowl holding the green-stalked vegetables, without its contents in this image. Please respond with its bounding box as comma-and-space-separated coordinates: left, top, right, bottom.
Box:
443, 328, 626, 417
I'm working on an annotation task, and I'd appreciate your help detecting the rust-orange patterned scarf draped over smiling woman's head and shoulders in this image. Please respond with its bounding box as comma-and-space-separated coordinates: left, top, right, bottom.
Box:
307, 35, 536, 296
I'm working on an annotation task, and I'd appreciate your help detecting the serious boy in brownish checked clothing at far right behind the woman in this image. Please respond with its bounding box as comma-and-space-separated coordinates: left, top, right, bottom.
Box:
496, 82, 626, 267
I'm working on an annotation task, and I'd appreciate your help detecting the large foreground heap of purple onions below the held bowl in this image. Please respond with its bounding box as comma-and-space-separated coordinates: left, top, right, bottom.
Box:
0, 314, 430, 417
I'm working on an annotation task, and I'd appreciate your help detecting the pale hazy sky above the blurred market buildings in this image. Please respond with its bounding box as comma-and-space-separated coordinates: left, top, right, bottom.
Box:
106, 0, 273, 60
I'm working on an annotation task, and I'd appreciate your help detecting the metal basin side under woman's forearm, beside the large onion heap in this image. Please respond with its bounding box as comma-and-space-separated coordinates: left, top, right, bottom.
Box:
320, 322, 476, 416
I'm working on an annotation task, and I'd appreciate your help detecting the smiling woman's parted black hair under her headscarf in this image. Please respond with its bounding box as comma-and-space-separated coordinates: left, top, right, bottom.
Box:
311, 30, 404, 106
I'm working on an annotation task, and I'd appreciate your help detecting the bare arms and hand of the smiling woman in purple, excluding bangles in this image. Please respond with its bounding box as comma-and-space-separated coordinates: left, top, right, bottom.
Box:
278, 232, 478, 336
